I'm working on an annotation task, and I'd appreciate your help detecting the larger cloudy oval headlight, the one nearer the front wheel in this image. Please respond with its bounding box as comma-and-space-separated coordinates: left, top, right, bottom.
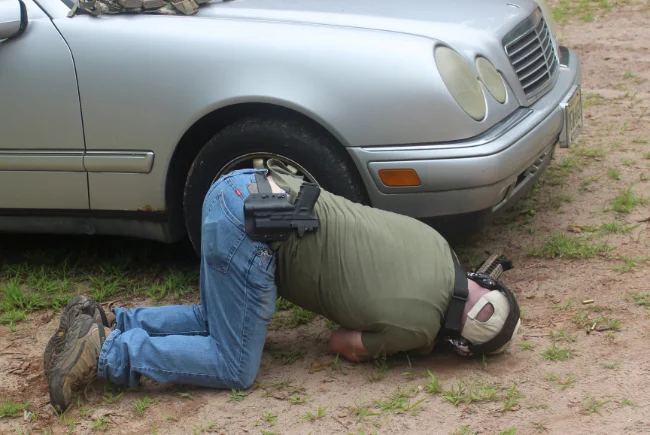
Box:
434, 45, 486, 121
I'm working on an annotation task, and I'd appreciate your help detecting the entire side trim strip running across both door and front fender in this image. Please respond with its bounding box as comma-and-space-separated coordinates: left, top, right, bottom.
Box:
0, 150, 154, 174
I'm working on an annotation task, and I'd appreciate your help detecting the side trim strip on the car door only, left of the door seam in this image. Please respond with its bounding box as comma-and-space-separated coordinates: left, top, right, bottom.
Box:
0, 150, 85, 172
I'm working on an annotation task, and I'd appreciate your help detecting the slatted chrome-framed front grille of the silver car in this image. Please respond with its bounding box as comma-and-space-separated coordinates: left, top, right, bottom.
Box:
504, 10, 559, 98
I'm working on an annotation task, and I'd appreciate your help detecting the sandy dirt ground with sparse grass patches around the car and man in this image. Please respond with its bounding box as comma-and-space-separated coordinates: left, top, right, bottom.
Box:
0, 1, 650, 434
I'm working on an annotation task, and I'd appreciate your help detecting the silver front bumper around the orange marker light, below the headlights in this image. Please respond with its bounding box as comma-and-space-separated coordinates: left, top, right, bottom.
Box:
349, 47, 581, 223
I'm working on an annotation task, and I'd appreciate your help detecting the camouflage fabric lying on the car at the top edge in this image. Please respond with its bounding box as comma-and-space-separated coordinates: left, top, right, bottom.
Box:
68, 0, 212, 18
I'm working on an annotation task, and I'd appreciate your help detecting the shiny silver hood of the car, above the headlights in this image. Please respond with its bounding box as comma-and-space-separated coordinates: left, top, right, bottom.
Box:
198, 0, 537, 45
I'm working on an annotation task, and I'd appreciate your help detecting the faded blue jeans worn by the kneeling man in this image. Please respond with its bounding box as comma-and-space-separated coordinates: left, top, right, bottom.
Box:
98, 169, 277, 389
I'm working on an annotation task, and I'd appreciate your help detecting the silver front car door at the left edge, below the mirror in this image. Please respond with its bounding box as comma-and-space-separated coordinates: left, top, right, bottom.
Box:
0, 0, 88, 210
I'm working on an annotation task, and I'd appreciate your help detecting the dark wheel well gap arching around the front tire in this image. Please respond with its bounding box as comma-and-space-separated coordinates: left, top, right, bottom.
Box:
165, 103, 365, 239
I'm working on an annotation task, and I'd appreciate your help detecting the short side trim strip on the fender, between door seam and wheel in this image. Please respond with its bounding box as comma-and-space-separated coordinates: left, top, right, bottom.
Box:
84, 151, 154, 174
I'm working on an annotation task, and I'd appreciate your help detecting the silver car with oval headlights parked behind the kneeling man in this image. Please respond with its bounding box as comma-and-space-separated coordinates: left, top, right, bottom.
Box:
0, 0, 582, 252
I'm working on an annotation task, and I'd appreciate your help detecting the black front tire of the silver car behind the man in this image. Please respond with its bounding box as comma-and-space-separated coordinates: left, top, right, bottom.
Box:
183, 118, 368, 254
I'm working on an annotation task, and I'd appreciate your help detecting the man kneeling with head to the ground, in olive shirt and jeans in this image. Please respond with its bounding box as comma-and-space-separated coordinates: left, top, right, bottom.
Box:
44, 160, 519, 412
